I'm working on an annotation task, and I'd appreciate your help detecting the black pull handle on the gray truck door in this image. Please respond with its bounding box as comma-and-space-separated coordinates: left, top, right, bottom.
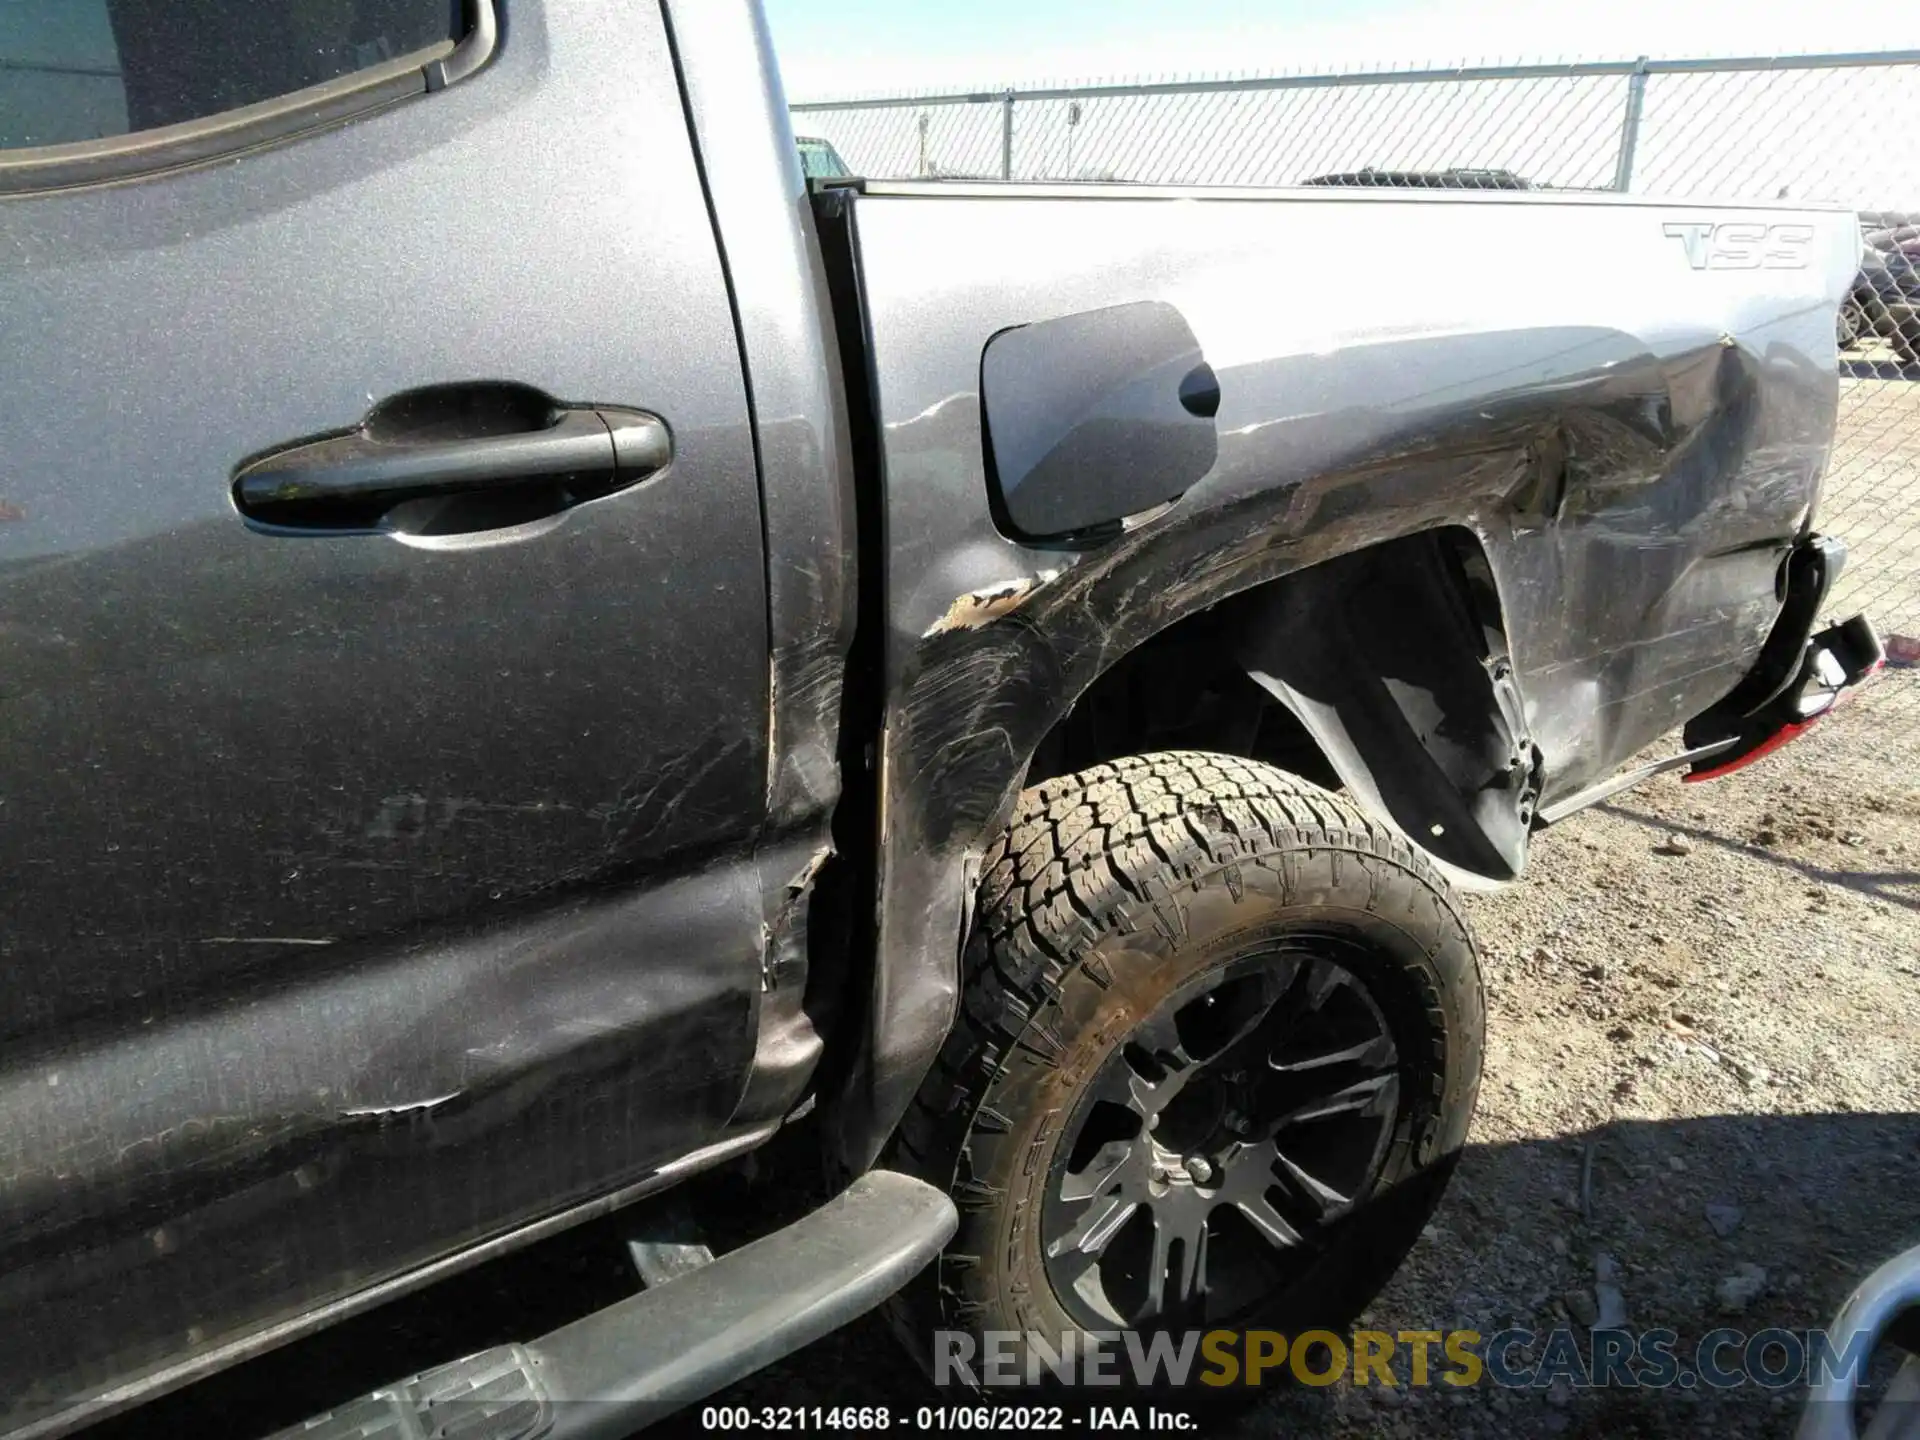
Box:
234, 397, 672, 534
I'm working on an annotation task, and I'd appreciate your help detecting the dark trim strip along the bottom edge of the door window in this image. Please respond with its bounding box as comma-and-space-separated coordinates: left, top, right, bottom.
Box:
0, 0, 499, 196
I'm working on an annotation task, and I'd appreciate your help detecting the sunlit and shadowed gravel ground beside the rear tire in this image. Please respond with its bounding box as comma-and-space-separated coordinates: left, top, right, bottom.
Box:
721, 672, 1920, 1440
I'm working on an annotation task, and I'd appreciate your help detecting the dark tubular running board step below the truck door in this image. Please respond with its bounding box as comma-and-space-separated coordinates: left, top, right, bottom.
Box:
271, 1169, 958, 1440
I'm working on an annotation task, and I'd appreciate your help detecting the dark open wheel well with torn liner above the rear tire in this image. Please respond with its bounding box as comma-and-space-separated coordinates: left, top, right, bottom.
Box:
1027, 526, 1540, 881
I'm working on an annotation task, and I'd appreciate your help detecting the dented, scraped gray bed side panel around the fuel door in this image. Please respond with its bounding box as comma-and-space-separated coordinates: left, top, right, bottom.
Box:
845, 186, 1857, 1158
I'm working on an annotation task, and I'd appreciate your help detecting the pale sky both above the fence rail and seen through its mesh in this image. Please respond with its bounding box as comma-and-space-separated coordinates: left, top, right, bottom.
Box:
764, 0, 1920, 209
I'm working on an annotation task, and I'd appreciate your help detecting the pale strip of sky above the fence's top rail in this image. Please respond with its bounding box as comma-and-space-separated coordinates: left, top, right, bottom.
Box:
764, 0, 1920, 100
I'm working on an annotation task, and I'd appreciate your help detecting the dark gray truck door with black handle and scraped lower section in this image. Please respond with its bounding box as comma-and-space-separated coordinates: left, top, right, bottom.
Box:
0, 0, 768, 1430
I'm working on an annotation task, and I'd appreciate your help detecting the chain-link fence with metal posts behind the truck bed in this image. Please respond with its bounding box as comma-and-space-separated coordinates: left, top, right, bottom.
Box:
793, 52, 1920, 726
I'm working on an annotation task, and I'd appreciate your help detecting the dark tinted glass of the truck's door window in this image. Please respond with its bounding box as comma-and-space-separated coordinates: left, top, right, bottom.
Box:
0, 0, 470, 152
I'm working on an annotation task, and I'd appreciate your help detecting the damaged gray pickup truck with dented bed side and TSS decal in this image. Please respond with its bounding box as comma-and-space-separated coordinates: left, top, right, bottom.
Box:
0, 0, 1876, 1440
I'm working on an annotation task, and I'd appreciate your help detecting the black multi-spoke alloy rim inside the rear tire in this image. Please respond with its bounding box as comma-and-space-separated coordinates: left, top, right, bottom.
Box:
1043, 933, 1402, 1329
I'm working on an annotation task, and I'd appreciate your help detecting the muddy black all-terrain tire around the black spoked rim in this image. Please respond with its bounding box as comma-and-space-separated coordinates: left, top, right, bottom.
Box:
891, 753, 1484, 1390
